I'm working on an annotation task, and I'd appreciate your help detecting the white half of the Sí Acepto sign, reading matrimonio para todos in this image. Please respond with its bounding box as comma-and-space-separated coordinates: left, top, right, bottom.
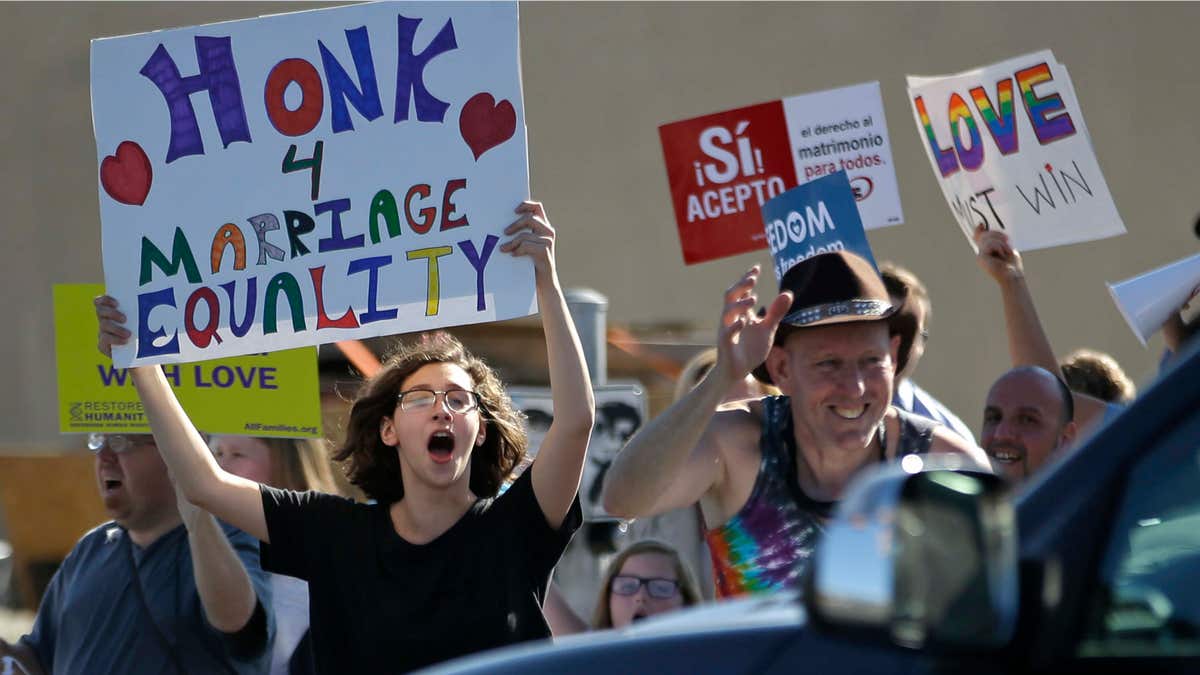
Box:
784, 82, 904, 229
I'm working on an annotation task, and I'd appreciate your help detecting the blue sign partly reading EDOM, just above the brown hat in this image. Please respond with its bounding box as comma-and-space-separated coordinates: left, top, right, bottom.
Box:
762, 171, 878, 281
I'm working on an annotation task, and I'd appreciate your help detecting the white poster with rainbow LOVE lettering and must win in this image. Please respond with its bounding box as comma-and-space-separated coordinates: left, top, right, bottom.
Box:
908, 50, 1126, 250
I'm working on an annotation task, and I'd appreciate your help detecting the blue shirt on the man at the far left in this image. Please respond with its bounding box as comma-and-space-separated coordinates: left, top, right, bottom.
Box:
22, 522, 275, 674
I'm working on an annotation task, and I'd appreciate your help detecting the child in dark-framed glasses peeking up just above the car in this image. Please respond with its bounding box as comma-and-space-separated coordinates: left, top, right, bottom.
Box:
592, 539, 700, 628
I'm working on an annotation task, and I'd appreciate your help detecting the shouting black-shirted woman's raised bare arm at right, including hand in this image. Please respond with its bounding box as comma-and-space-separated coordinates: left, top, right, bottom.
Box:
500, 202, 595, 530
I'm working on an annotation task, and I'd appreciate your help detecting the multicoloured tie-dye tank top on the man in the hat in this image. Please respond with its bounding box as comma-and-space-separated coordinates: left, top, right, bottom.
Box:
704, 396, 937, 598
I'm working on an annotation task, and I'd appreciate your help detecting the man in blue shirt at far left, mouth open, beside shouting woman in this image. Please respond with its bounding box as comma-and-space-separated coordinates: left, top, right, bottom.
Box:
0, 434, 274, 675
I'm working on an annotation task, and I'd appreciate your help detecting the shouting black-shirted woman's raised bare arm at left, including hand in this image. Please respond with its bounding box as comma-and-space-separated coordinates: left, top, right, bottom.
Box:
95, 295, 268, 542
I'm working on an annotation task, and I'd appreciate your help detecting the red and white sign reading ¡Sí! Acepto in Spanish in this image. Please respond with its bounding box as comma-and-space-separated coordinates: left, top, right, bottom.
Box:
659, 82, 904, 264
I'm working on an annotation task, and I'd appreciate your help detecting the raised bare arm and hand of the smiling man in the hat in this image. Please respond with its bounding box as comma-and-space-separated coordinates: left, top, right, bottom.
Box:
604, 265, 791, 518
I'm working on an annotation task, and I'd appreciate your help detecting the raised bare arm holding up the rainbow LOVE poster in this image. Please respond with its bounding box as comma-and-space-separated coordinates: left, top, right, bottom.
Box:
974, 226, 1106, 429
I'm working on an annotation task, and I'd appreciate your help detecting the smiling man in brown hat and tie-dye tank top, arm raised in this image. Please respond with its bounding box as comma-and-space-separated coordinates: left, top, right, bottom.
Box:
604, 251, 988, 597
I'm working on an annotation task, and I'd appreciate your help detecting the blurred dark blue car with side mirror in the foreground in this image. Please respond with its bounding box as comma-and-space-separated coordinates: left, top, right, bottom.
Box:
436, 345, 1200, 675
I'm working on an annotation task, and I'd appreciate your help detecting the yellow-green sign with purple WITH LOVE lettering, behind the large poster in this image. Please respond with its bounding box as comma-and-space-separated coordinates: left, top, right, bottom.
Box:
54, 283, 322, 438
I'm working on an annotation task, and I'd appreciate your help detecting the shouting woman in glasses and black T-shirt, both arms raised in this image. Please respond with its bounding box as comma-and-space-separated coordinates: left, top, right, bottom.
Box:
96, 202, 595, 674
